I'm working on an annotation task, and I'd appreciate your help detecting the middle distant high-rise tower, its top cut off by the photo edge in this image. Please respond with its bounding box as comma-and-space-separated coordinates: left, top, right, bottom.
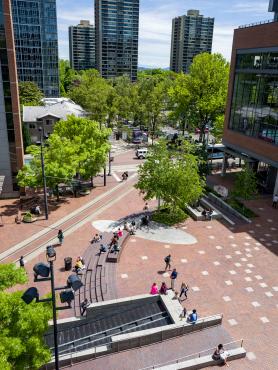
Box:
95, 0, 139, 81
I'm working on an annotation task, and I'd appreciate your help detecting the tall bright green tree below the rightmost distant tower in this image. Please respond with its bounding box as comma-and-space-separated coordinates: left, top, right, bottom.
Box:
187, 53, 229, 141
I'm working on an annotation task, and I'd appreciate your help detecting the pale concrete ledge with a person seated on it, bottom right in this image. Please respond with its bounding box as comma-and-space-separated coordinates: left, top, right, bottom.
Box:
156, 347, 246, 370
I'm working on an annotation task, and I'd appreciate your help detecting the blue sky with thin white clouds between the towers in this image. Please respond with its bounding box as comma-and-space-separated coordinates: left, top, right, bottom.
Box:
56, 0, 273, 68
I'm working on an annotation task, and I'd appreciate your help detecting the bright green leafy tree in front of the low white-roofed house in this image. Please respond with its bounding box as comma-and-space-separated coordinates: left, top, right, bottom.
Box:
17, 116, 111, 189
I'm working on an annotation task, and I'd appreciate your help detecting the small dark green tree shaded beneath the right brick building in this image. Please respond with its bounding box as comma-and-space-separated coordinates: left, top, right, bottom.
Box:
232, 165, 258, 200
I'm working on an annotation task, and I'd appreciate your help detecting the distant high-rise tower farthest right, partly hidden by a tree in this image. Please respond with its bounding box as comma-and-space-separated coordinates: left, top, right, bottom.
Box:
170, 10, 214, 73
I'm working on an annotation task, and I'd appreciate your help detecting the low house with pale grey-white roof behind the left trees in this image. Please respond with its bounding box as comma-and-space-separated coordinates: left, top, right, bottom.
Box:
23, 98, 87, 143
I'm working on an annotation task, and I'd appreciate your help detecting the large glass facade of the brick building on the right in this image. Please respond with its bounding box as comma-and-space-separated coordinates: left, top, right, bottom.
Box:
229, 48, 278, 145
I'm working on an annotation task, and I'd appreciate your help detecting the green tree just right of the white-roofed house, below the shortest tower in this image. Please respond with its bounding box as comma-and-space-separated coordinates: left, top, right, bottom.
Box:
68, 69, 113, 127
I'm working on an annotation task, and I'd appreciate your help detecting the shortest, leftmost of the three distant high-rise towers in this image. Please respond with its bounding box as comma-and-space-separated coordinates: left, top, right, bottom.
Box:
69, 21, 96, 71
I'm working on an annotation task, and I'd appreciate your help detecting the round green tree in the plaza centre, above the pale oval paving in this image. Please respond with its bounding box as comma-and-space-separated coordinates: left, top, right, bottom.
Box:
135, 141, 204, 210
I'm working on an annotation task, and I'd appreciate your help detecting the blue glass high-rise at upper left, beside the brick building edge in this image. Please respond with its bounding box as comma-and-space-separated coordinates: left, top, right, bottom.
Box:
11, 0, 59, 97
